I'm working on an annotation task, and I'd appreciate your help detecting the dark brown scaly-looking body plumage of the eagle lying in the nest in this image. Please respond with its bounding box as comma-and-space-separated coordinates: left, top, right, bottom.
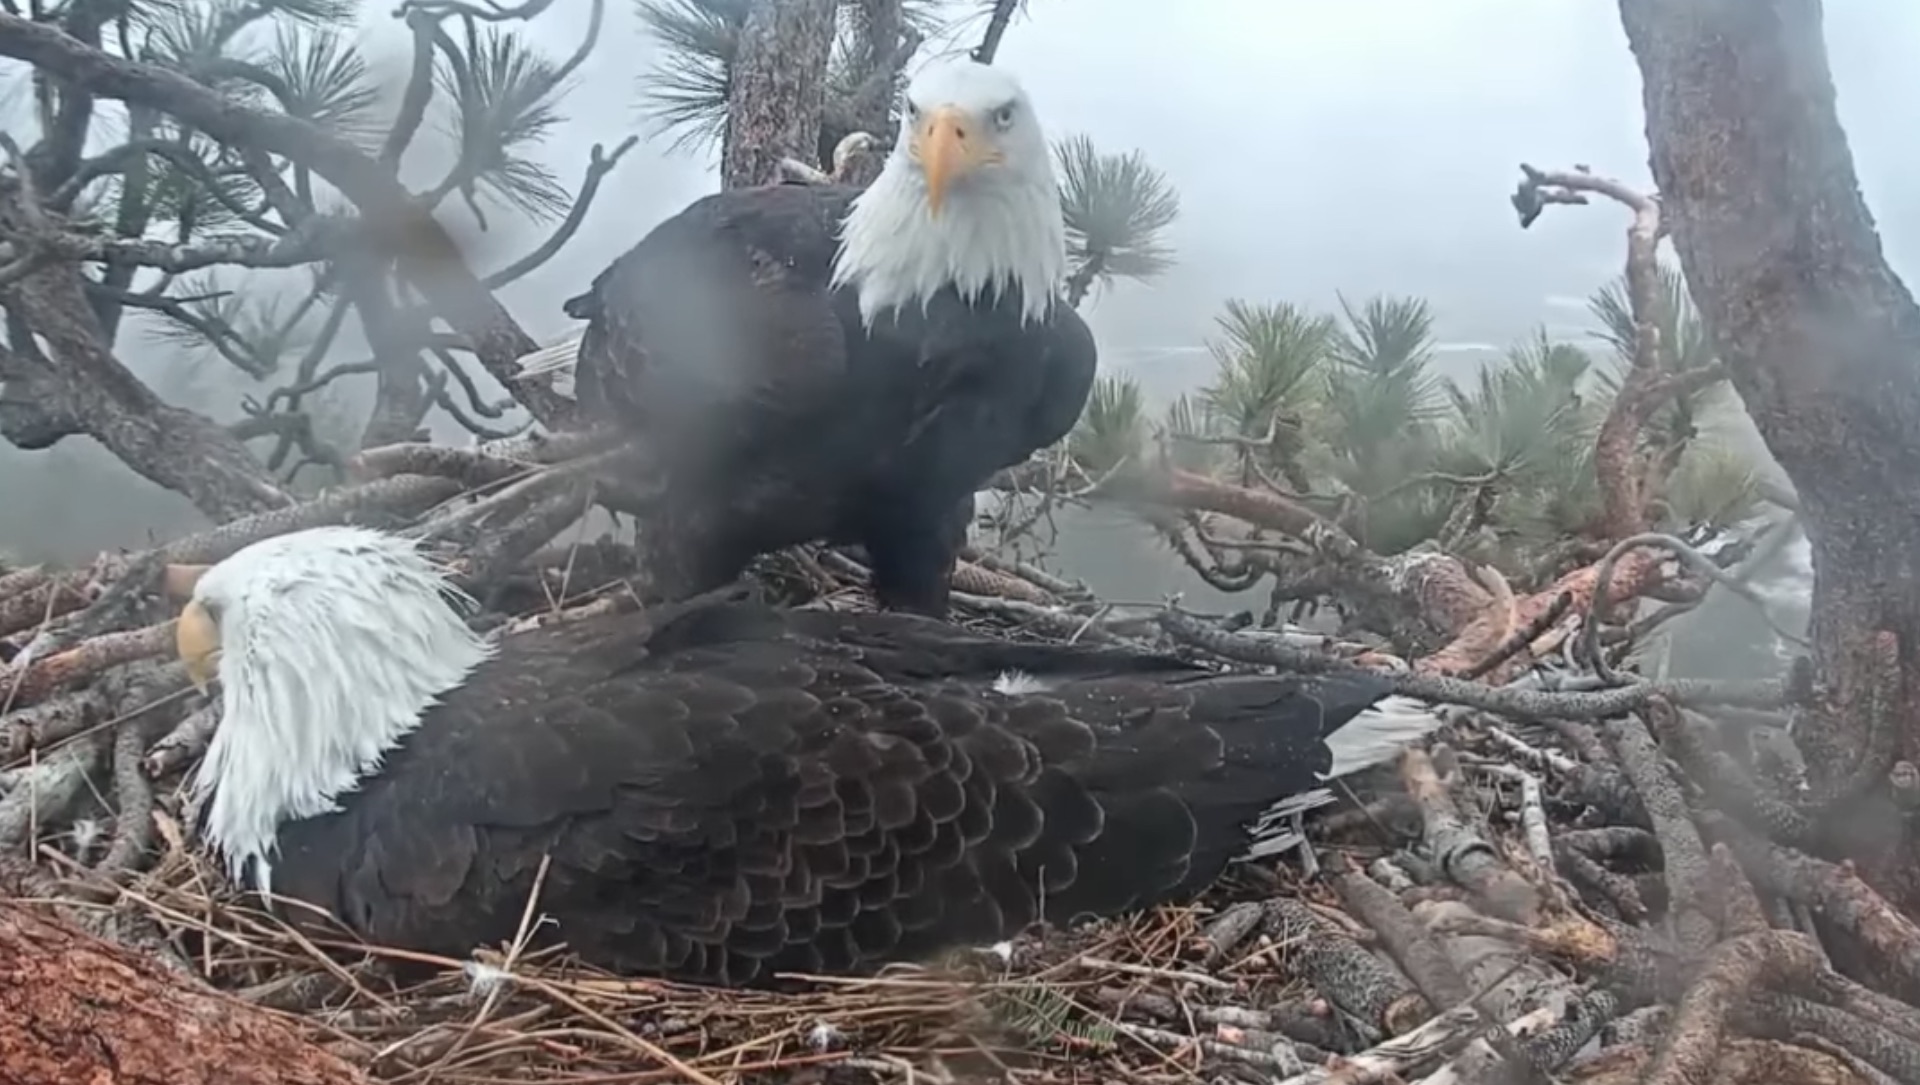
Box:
273, 601, 1420, 985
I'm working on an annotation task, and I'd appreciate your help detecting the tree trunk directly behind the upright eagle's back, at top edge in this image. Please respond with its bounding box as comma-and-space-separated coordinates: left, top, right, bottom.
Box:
720, 0, 839, 188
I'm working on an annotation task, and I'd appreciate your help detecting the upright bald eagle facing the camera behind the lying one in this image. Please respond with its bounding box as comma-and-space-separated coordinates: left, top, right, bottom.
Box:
522, 61, 1096, 616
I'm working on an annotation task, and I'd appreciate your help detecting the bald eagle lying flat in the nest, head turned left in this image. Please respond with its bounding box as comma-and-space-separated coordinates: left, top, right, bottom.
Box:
177, 528, 1438, 983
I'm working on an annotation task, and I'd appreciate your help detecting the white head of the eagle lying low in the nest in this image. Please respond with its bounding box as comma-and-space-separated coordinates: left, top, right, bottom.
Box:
169, 528, 493, 891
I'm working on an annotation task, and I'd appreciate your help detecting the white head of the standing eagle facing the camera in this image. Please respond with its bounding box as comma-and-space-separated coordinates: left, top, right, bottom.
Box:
833, 60, 1068, 325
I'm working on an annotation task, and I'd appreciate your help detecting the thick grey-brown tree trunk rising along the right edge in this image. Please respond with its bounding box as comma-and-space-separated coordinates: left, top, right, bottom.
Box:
1620, 0, 1920, 891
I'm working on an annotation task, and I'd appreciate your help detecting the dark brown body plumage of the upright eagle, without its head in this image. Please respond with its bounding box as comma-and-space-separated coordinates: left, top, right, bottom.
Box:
566, 184, 1096, 616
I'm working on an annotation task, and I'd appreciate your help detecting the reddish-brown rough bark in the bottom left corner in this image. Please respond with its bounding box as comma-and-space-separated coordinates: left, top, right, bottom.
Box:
0, 901, 367, 1085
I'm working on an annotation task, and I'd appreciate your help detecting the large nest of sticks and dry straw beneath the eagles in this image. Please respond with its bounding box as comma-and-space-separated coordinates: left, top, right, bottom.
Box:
0, 440, 1920, 1085
